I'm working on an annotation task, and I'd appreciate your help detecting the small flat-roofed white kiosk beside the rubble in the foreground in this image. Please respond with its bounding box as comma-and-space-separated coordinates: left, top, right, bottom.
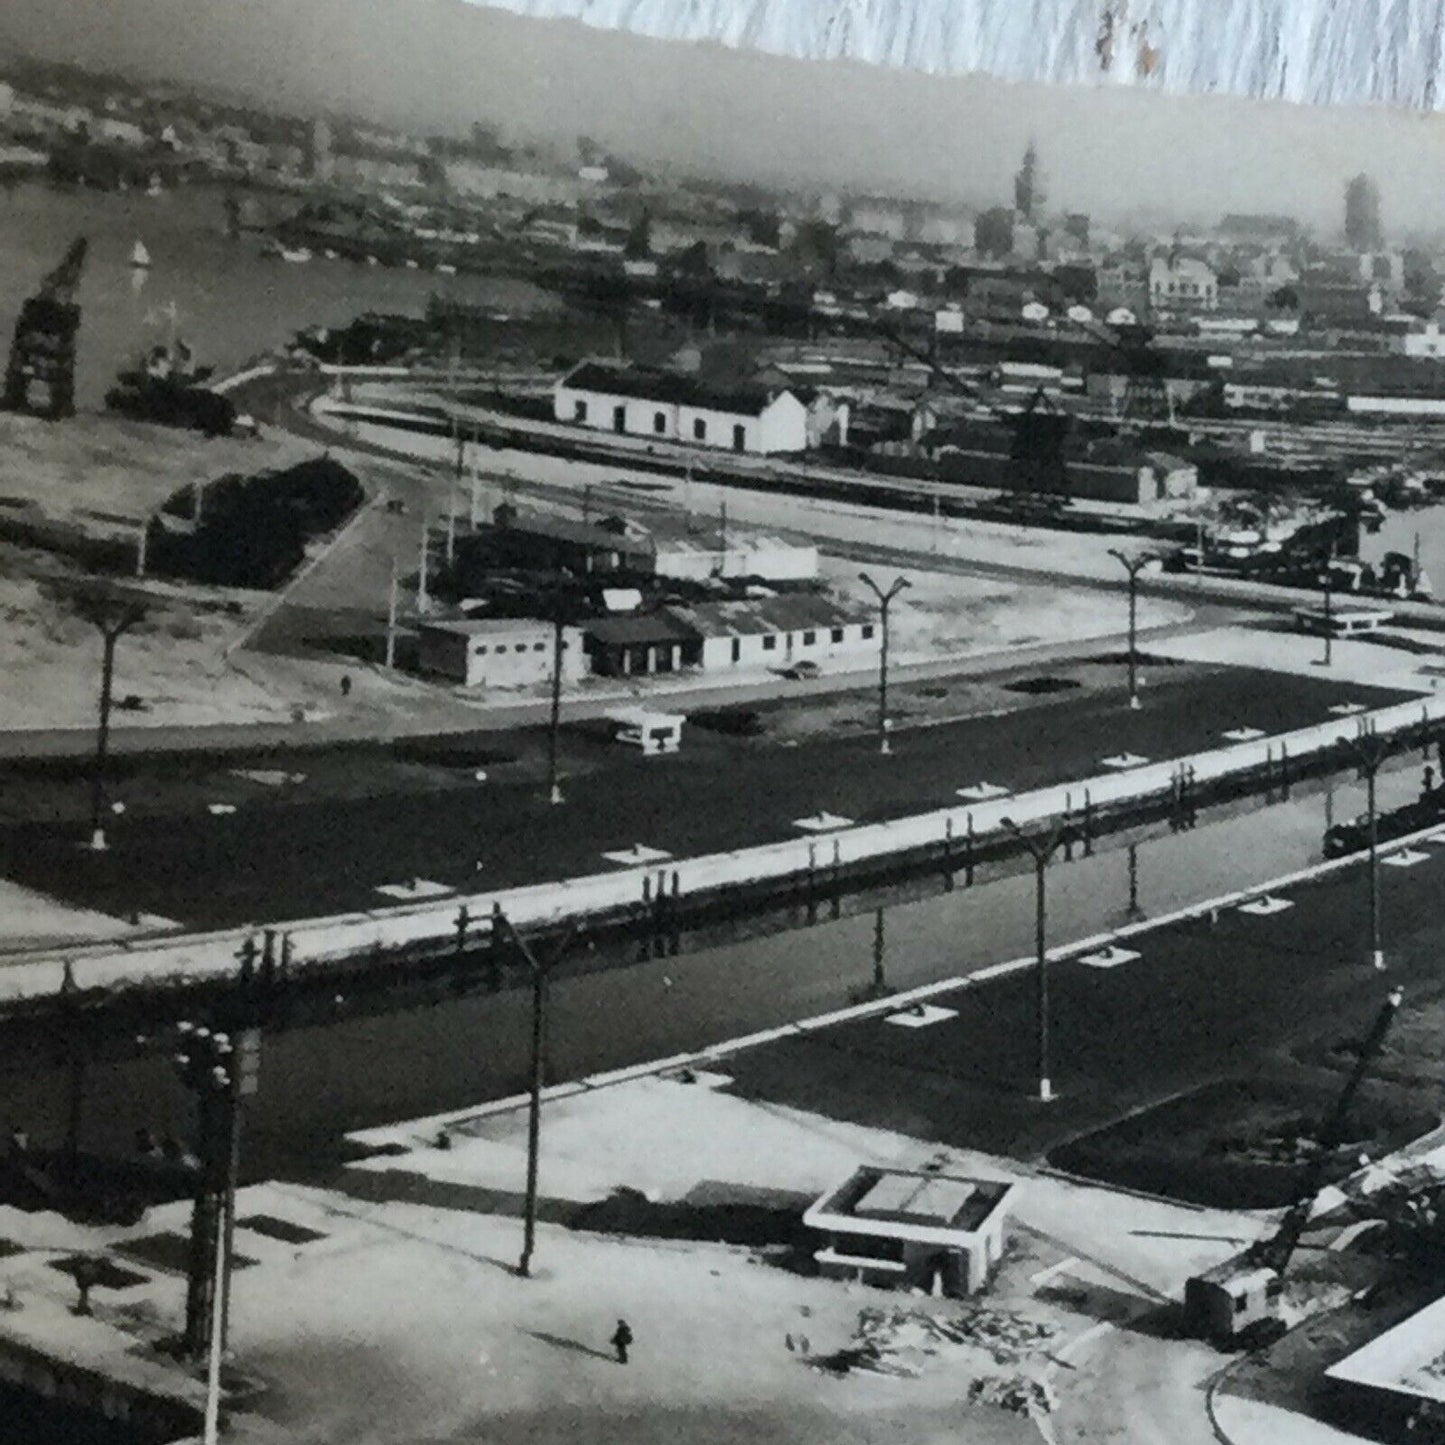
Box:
803, 1168, 1013, 1296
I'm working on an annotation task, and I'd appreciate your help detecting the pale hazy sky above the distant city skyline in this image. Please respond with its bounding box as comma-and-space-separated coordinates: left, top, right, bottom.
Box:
8, 0, 1445, 233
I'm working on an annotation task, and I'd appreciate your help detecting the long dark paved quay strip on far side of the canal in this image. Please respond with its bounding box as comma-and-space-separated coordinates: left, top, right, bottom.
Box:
0, 666, 1402, 926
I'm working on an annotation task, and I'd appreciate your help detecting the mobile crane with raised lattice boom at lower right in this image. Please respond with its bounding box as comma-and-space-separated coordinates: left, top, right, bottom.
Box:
1183, 988, 1403, 1345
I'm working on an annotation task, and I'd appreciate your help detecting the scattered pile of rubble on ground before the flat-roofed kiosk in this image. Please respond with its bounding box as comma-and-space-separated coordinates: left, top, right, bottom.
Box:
809, 1306, 1059, 1413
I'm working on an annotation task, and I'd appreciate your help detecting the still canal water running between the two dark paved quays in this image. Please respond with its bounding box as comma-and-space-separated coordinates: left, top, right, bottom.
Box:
0, 759, 1420, 1178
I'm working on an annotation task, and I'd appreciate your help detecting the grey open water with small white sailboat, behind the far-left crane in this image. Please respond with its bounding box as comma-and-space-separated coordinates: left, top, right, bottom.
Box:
0, 182, 558, 410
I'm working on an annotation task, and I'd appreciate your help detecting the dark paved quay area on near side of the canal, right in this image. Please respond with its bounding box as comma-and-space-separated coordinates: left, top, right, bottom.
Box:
730, 814, 1445, 1157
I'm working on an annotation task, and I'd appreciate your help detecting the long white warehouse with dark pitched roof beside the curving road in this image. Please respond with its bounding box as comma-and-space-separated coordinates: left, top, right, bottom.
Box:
553, 361, 808, 455
